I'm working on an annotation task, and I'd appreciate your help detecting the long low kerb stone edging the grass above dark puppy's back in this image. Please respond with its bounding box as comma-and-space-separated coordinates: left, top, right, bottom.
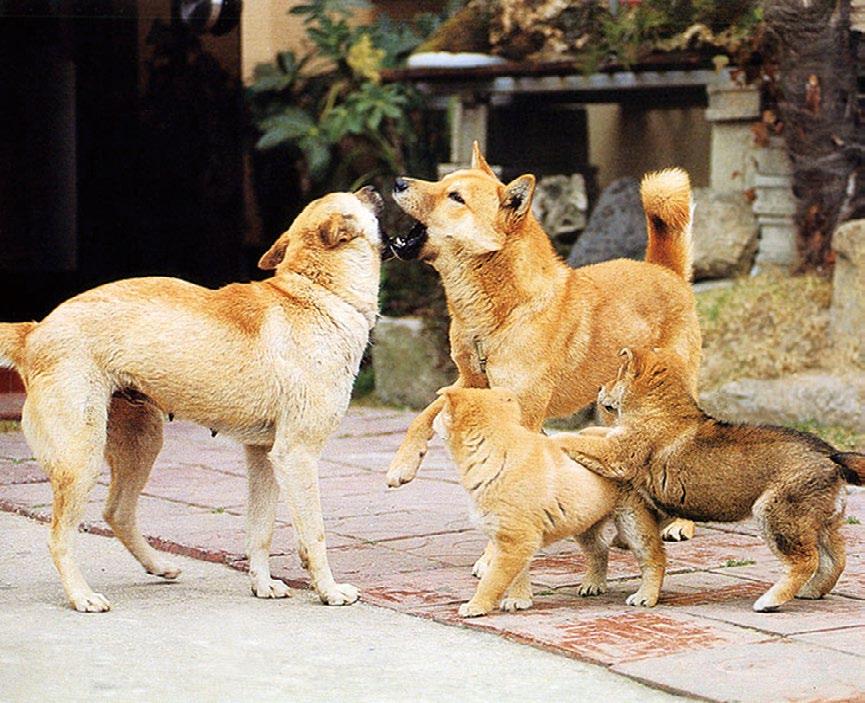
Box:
700, 372, 865, 432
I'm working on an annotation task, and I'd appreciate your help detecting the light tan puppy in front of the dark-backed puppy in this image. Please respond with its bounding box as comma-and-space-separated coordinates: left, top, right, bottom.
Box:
433, 388, 664, 617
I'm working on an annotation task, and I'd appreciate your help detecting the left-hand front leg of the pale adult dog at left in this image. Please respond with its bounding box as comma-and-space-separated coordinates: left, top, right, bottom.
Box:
245, 445, 297, 598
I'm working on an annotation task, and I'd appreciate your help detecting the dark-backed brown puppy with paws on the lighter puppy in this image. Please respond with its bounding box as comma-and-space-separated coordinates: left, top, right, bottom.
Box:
553, 349, 865, 612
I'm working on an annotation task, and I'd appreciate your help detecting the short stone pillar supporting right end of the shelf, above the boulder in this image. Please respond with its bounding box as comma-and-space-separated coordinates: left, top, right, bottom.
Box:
706, 81, 760, 193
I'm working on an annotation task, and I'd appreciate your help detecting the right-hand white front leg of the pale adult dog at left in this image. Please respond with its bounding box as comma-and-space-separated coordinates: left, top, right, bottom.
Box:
268, 437, 358, 605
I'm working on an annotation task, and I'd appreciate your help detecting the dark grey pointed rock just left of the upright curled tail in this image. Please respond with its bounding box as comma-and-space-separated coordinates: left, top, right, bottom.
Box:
568, 177, 646, 268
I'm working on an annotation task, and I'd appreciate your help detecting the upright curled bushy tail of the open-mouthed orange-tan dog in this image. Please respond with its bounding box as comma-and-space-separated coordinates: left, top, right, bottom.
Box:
640, 168, 694, 281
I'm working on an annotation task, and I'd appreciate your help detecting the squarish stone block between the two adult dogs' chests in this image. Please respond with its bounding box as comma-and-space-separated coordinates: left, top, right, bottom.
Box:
372, 317, 457, 409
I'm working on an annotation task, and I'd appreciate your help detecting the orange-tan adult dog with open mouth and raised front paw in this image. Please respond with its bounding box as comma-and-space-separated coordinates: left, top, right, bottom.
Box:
387, 144, 701, 571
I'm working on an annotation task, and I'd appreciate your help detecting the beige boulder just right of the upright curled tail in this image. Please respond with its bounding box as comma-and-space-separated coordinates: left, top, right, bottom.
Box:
692, 188, 759, 280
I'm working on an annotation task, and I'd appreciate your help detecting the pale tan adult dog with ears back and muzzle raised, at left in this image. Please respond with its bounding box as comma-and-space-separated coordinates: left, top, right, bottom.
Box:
0, 188, 381, 612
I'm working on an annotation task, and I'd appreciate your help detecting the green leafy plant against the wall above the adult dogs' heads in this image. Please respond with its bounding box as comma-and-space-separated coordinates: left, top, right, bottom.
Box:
243, 0, 446, 189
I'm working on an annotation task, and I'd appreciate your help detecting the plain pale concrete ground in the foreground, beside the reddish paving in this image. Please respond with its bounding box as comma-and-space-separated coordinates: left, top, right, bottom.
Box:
0, 513, 682, 703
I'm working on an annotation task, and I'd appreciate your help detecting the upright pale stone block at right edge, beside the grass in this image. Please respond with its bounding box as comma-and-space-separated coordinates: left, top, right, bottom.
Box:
829, 220, 865, 364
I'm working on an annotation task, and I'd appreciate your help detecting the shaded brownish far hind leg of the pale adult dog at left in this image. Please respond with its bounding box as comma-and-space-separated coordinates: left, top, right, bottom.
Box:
104, 397, 180, 579
